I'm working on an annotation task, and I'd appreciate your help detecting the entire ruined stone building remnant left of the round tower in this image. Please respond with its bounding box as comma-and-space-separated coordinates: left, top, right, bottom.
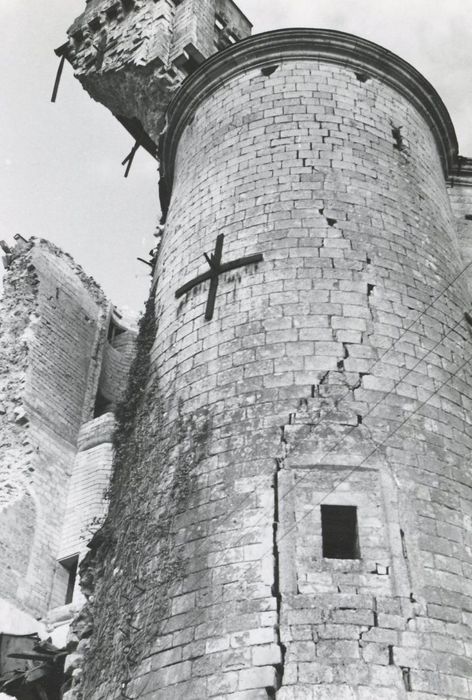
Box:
0, 236, 135, 684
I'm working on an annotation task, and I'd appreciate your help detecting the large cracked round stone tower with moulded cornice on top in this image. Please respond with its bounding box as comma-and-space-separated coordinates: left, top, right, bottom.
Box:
60, 0, 472, 700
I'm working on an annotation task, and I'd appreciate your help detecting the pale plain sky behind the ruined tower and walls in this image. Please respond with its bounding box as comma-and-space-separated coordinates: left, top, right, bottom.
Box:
0, 0, 472, 312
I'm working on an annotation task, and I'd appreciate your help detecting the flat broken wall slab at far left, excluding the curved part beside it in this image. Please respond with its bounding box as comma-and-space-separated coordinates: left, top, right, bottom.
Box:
0, 239, 108, 616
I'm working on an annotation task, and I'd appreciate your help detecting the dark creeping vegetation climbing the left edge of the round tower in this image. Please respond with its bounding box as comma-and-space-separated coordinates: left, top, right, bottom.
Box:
77, 296, 207, 698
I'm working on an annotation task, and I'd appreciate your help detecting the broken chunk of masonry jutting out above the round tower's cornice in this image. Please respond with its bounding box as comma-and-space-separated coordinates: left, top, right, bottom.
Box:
57, 0, 252, 148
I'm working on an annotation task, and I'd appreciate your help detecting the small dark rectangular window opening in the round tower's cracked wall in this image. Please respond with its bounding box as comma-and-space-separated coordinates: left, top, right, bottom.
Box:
321, 505, 360, 559
